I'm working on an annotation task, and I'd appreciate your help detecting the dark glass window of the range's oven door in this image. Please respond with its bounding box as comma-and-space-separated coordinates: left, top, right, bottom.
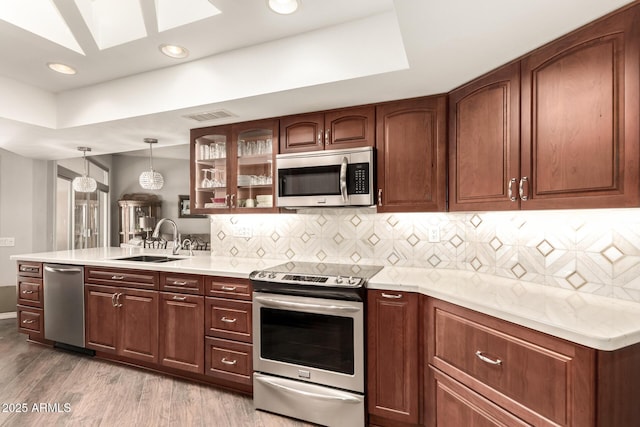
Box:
260, 308, 354, 375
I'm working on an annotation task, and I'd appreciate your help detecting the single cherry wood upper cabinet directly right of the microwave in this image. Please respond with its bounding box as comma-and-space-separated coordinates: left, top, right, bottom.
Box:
376, 96, 447, 212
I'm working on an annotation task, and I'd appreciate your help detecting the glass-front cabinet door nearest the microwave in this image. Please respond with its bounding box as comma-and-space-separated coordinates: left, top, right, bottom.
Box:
234, 120, 278, 209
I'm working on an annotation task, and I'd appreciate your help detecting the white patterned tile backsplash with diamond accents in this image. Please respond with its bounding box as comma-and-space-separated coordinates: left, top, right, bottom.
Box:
211, 208, 640, 302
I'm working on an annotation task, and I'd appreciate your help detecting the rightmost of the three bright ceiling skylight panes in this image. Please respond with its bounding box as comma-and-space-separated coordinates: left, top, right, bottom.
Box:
155, 0, 222, 32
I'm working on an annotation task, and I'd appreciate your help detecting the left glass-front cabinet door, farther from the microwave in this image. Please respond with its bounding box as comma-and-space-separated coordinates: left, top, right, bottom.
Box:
192, 131, 231, 210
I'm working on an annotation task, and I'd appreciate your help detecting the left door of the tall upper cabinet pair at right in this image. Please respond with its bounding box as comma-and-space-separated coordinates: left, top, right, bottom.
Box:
449, 62, 521, 211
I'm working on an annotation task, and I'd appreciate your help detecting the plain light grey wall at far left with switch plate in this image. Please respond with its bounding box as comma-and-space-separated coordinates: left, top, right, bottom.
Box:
0, 149, 55, 313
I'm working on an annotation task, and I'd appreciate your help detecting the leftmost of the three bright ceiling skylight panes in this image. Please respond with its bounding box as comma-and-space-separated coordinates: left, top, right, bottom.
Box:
0, 0, 84, 55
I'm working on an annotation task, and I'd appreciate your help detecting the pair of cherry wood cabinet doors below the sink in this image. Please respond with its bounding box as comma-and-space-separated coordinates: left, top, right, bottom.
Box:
85, 285, 158, 363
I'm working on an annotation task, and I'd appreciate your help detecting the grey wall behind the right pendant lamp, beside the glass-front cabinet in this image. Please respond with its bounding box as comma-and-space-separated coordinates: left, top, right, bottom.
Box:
110, 154, 209, 246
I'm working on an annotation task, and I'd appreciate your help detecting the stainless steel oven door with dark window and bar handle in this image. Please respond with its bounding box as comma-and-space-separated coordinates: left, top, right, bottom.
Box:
253, 292, 364, 393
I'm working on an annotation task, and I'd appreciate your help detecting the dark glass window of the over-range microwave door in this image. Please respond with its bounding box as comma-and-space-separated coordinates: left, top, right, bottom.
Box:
278, 165, 340, 196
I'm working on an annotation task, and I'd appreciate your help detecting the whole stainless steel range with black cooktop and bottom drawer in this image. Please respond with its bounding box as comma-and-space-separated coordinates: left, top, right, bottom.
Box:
250, 262, 382, 427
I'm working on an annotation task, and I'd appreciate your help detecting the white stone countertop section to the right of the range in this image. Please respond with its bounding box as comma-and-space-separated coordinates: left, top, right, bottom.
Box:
367, 267, 640, 351
